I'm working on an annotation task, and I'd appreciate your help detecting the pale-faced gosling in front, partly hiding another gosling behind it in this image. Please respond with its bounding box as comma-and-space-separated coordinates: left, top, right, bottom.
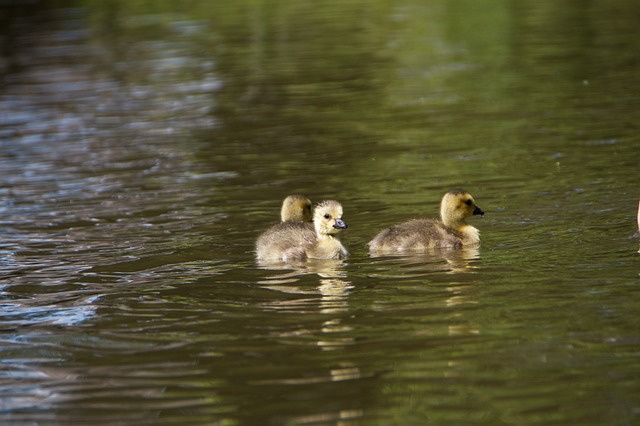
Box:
256, 200, 349, 262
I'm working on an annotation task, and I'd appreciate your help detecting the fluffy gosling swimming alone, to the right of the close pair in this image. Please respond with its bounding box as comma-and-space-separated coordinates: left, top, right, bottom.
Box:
369, 190, 484, 253
